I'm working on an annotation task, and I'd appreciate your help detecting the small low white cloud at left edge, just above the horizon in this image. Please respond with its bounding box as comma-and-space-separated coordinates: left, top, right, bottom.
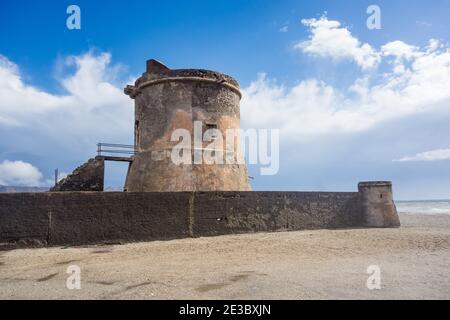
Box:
0, 160, 42, 186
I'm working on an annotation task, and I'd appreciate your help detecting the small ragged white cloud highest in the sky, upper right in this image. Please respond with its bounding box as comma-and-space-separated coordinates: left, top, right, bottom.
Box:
295, 16, 380, 70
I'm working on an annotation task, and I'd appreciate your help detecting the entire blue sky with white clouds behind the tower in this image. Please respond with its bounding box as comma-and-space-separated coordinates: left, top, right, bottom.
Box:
0, 0, 450, 199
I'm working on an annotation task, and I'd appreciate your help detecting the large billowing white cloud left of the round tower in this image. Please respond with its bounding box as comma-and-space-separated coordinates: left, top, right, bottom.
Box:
0, 52, 132, 134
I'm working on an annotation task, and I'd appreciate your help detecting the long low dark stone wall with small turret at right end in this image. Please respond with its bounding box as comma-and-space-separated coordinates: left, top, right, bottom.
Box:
0, 183, 399, 248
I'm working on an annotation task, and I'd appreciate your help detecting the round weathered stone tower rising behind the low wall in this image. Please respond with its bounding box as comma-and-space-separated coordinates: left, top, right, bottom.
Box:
125, 60, 250, 192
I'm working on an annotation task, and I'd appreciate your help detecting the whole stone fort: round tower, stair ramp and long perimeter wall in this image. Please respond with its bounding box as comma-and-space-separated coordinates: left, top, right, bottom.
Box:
0, 60, 400, 248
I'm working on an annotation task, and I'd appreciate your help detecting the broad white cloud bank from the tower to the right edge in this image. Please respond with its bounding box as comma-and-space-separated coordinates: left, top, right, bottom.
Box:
242, 17, 450, 138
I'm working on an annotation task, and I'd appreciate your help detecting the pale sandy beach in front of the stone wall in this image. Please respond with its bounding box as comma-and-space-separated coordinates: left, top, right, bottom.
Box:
0, 214, 450, 299
